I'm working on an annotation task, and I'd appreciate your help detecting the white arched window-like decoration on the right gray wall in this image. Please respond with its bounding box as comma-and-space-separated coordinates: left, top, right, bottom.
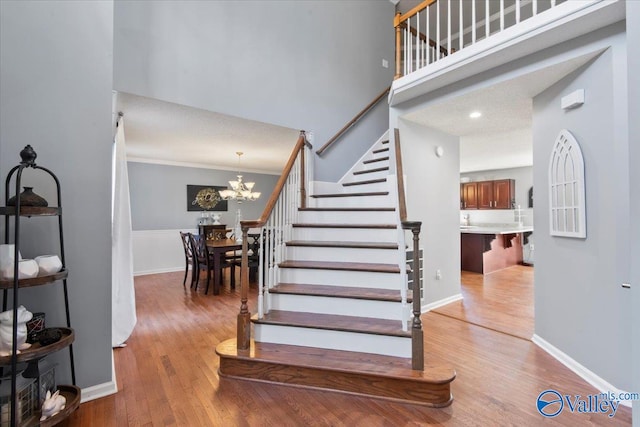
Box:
549, 129, 587, 238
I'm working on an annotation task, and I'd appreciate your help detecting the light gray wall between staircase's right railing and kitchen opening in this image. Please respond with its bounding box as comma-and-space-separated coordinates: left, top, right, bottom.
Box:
398, 120, 460, 304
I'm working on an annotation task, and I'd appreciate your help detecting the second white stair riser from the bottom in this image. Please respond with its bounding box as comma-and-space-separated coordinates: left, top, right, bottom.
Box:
271, 291, 402, 321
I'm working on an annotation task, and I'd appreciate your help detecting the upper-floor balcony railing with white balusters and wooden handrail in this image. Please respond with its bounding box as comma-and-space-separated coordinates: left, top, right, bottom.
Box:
394, 0, 567, 79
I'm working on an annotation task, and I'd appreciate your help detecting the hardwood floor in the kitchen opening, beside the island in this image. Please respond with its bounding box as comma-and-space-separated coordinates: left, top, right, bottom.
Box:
434, 265, 534, 340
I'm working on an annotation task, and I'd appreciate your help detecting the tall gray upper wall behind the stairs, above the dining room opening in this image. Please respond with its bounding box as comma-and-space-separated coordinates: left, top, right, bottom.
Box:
114, 0, 394, 181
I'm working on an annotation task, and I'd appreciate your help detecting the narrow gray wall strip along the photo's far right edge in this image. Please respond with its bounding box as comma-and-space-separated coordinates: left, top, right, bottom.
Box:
626, 1, 640, 426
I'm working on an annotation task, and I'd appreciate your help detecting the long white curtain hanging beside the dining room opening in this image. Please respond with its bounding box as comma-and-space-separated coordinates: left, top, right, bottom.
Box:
111, 117, 137, 347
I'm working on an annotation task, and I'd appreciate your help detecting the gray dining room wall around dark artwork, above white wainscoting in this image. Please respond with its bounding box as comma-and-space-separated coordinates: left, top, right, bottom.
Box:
128, 162, 278, 230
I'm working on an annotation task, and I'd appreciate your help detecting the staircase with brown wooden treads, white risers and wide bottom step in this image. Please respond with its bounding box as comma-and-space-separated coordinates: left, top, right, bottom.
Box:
216, 135, 455, 406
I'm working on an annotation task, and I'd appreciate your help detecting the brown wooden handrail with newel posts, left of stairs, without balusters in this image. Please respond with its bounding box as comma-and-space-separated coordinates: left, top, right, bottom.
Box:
236, 131, 312, 352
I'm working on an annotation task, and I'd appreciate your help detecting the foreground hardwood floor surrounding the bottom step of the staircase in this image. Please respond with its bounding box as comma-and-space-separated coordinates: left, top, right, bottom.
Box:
60, 272, 631, 427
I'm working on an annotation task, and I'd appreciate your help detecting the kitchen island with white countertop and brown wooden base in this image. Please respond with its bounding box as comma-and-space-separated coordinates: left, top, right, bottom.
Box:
460, 224, 533, 274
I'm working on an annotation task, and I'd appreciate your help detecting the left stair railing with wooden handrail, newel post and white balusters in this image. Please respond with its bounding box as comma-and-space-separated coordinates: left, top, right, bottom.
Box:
237, 131, 313, 350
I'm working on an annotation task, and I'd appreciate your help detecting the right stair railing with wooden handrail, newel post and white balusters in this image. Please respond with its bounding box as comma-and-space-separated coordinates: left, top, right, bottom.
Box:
394, 128, 424, 371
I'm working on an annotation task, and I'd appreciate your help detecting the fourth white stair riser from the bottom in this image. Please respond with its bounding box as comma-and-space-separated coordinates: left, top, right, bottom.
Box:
287, 246, 400, 263
